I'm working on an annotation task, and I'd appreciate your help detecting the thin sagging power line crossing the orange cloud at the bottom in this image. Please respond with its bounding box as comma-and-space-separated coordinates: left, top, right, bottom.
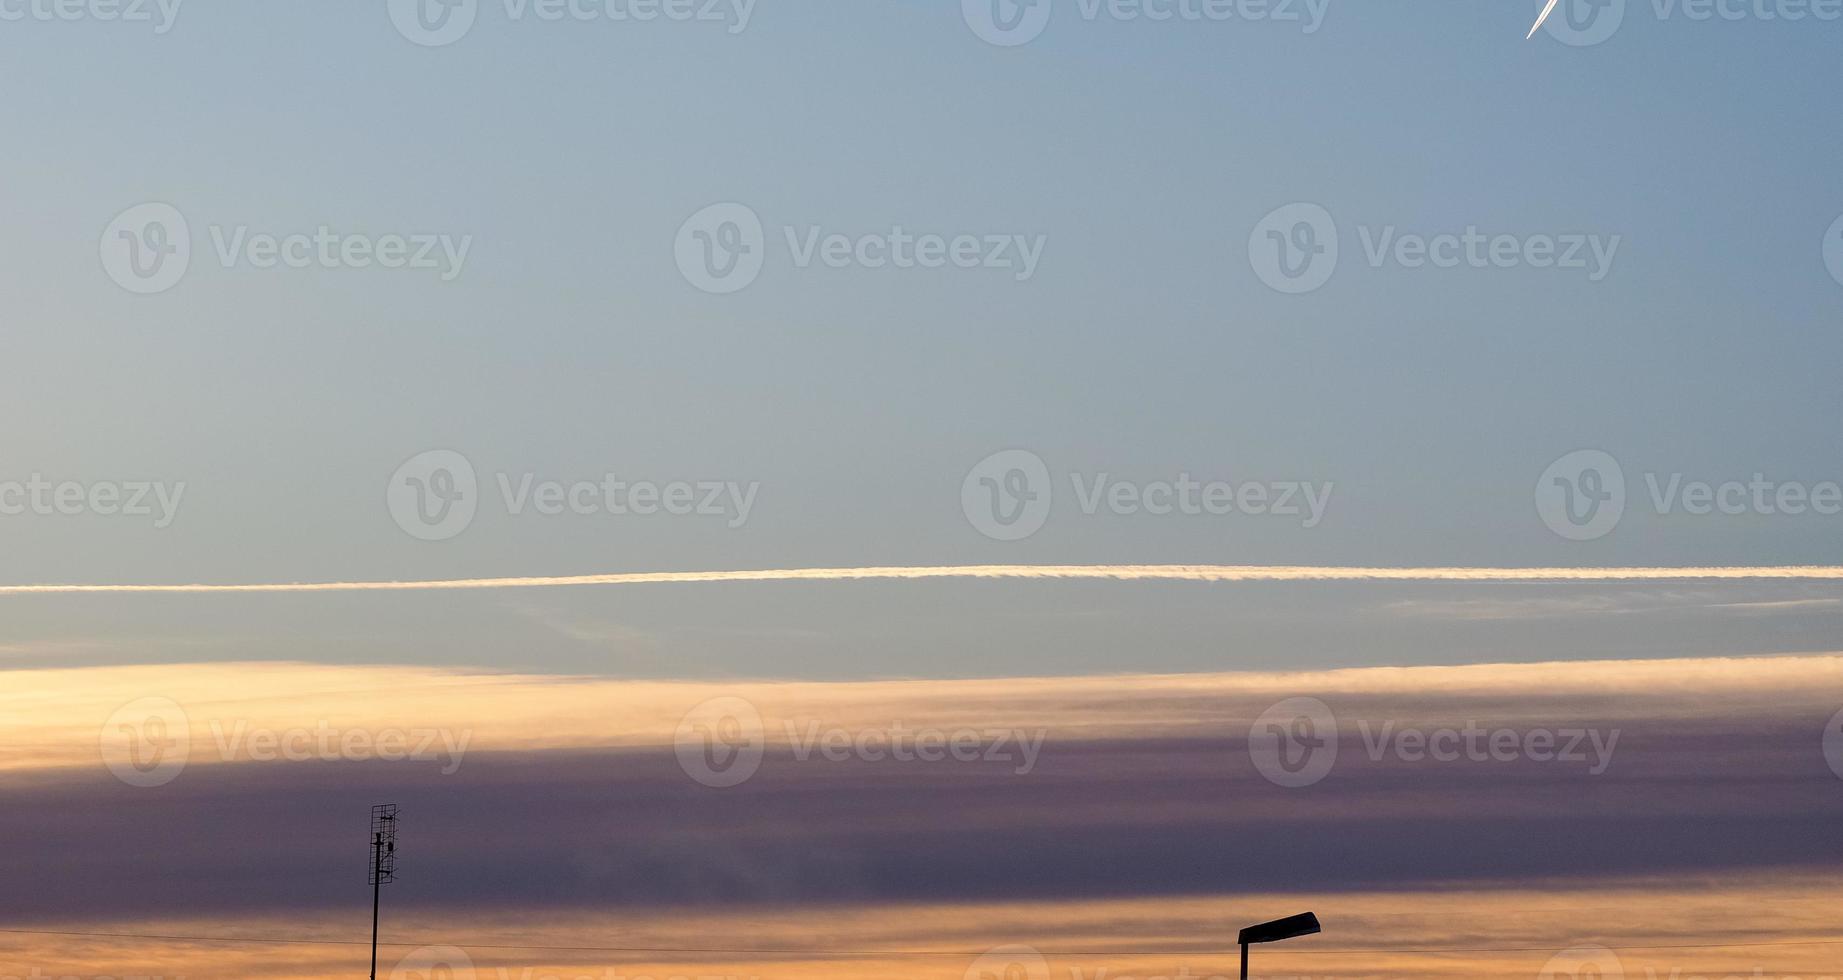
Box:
0, 928, 1843, 960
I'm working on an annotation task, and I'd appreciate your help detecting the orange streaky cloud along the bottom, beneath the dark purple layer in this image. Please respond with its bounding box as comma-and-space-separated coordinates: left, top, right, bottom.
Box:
0, 875, 1836, 980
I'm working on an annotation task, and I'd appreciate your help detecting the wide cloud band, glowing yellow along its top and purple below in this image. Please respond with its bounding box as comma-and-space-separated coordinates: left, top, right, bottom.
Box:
0, 656, 1843, 921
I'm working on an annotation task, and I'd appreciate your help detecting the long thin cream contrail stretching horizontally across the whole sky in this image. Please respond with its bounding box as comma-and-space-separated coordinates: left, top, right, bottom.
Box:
0, 566, 1843, 595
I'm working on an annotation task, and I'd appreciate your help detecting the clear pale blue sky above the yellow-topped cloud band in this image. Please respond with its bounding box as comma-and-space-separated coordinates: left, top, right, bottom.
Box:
0, 2, 1843, 672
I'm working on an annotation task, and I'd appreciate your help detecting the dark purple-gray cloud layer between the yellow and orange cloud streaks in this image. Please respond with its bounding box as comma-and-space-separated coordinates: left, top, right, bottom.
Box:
0, 700, 1843, 921
